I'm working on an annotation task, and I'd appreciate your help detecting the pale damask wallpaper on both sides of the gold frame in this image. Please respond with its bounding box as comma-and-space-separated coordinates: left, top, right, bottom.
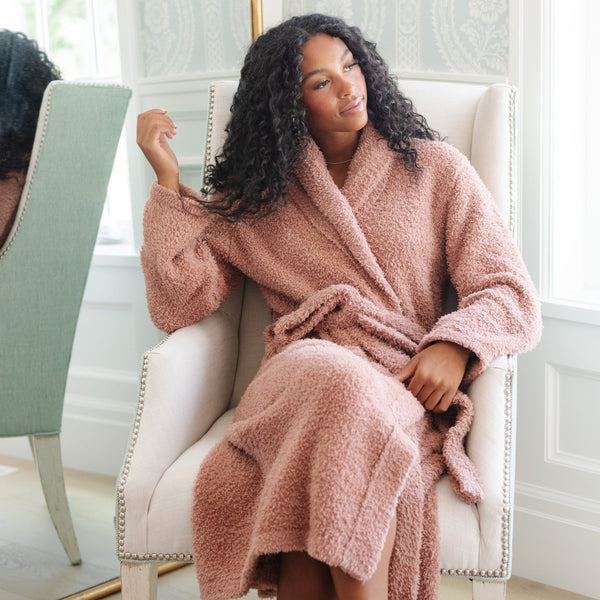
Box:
139, 0, 509, 79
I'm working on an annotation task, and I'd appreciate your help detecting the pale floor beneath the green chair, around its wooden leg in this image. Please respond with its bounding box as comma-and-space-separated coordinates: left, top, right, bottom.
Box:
0, 455, 119, 600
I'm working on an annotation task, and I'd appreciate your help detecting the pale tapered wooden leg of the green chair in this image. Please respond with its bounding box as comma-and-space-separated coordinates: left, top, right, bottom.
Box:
29, 434, 81, 565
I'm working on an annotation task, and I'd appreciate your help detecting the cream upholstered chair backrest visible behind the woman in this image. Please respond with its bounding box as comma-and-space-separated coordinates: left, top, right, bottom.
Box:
205, 79, 516, 406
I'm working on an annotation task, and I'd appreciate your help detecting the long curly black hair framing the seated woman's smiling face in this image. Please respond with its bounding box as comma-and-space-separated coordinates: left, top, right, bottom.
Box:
201, 14, 439, 221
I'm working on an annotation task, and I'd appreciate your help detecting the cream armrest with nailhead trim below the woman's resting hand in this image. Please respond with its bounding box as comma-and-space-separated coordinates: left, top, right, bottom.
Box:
466, 357, 514, 566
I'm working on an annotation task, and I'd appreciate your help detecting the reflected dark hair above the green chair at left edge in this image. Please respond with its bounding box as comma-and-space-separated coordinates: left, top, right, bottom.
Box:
0, 29, 60, 180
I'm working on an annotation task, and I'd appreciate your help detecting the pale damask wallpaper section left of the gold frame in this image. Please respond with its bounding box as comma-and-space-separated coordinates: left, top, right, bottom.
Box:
139, 0, 250, 77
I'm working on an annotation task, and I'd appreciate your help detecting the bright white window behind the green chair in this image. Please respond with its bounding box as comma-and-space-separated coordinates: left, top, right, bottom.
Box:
0, 0, 132, 244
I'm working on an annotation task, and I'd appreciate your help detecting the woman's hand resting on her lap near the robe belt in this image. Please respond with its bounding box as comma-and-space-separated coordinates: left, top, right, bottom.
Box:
396, 342, 471, 413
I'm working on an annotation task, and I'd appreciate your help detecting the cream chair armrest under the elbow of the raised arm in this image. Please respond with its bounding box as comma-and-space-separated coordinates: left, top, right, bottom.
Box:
118, 294, 241, 546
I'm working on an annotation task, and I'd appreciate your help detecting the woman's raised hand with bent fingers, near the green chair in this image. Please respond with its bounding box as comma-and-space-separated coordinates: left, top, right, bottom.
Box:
137, 108, 179, 193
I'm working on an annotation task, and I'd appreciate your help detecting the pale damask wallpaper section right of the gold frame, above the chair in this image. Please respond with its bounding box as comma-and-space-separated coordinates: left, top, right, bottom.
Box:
283, 0, 509, 77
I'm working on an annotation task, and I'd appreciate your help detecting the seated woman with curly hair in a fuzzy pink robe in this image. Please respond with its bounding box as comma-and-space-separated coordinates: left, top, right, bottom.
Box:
138, 10, 540, 600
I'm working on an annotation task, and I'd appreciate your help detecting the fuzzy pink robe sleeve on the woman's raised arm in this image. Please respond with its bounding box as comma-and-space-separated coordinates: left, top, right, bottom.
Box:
141, 182, 241, 333
